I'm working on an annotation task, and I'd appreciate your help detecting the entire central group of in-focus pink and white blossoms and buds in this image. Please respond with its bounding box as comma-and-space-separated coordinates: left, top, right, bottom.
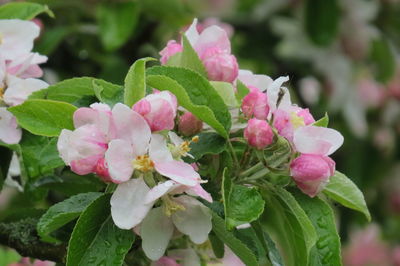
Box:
57, 20, 343, 261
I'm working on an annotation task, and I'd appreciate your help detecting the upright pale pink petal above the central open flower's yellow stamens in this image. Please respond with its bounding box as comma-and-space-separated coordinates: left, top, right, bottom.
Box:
112, 103, 151, 156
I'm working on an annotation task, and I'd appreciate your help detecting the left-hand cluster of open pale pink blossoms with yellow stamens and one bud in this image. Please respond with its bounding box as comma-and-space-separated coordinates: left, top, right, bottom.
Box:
57, 92, 212, 260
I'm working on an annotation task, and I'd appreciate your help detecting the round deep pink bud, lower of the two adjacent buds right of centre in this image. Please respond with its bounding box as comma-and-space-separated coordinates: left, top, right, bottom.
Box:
244, 118, 274, 150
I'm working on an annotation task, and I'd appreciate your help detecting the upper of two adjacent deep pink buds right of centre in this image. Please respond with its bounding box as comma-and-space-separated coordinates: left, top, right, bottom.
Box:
242, 86, 269, 120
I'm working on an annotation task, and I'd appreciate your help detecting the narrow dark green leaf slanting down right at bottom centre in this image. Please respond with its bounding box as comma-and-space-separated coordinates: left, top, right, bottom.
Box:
212, 212, 258, 266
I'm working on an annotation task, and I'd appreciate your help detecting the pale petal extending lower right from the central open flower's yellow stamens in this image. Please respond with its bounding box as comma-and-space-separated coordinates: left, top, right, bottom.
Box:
154, 161, 200, 187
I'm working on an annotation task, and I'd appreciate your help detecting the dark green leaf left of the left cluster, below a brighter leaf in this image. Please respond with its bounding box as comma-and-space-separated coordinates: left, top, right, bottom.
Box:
19, 132, 64, 178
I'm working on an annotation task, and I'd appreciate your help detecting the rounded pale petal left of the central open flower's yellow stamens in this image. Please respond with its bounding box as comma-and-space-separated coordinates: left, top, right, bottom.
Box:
105, 139, 134, 183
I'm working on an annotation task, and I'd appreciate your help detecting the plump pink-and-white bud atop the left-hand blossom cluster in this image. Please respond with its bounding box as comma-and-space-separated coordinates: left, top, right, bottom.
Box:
132, 91, 178, 131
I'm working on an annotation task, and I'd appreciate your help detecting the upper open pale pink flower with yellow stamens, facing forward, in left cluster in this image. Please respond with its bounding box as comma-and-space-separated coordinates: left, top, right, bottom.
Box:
105, 104, 200, 186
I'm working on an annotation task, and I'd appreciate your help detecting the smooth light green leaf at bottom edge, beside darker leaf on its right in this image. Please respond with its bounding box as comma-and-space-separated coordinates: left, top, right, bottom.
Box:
261, 187, 317, 266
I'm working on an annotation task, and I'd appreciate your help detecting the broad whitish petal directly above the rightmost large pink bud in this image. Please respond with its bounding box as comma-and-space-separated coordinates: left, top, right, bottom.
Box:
293, 125, 344, 156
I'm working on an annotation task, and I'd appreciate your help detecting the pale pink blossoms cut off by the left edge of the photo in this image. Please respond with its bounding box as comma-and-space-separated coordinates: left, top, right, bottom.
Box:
0, 19, 48, 144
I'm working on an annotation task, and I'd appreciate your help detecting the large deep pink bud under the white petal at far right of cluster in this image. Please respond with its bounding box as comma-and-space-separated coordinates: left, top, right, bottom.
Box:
290, 154, 335, 197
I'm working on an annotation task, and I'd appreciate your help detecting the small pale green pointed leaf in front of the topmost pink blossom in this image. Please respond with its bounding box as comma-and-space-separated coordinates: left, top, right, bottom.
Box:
177, 34, 207, 78
